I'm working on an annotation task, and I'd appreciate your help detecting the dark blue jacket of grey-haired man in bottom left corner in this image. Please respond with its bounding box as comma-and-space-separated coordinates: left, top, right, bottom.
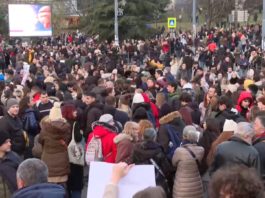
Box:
13, 183, 65, 198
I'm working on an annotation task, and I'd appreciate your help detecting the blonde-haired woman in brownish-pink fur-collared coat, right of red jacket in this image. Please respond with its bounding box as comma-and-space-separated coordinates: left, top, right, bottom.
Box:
114, 122, 140, 164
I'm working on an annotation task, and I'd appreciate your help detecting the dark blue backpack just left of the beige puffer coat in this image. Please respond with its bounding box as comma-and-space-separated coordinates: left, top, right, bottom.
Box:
165, 124, 181, 161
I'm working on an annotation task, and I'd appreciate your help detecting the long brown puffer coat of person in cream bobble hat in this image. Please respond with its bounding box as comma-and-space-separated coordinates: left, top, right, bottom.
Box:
39, 119, 71, 177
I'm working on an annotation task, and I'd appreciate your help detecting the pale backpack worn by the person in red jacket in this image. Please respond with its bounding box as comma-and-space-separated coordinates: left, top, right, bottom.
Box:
85, 134, 103, 165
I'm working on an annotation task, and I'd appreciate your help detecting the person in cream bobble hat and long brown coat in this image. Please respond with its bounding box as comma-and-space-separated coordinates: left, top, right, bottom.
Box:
39, 102, 71, 187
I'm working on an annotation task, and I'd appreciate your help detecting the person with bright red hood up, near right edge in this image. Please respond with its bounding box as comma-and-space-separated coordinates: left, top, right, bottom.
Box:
236, 91, 253, 118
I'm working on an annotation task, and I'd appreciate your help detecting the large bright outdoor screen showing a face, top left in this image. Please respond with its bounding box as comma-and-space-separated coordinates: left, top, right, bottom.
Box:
8, 4, 52, 37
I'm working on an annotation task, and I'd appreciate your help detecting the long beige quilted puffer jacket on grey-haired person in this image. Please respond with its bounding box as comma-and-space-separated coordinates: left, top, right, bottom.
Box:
172, 144, 204, 198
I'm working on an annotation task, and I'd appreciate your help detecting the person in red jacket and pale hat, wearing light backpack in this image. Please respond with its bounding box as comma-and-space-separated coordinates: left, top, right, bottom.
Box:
86, 114, 118, 163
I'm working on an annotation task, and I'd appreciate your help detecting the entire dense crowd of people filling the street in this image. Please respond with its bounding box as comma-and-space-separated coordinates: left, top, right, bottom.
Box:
0, 25, 265, 198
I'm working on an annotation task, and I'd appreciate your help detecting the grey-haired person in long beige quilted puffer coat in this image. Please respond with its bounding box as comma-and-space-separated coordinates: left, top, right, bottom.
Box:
172, 126, 204, 198
